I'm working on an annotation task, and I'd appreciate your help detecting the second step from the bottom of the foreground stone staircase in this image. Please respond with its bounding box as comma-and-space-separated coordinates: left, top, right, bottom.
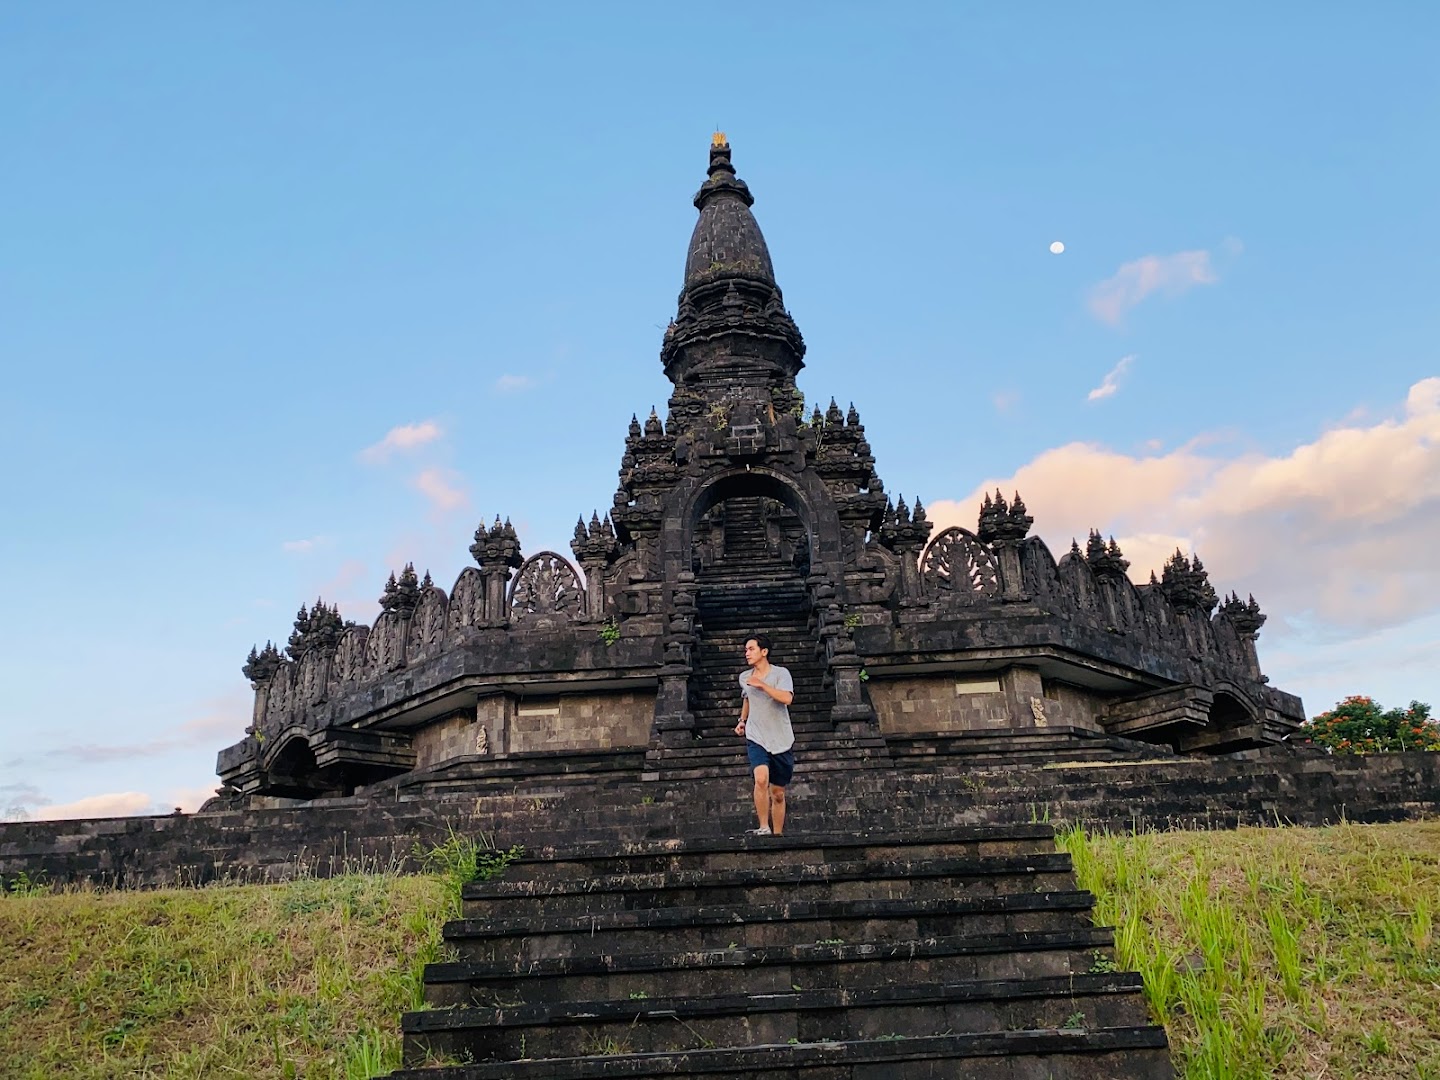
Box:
402, 972, 1146, 1061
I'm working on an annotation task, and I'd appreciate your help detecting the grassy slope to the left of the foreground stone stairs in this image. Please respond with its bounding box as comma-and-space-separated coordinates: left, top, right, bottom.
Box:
0, 837, 516, 1080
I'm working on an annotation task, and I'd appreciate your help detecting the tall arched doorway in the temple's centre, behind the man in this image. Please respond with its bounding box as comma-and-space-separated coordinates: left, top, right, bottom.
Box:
690, 472, 835, 756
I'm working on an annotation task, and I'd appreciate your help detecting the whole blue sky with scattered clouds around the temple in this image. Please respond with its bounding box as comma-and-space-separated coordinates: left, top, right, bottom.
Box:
0, 3, 1440, 816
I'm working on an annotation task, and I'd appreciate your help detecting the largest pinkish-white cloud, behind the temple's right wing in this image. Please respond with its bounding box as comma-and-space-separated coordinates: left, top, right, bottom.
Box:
929, 377, 1440, 638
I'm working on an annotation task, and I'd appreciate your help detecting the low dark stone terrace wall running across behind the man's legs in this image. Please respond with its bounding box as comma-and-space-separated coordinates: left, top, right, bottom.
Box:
11, 750, 1440, 887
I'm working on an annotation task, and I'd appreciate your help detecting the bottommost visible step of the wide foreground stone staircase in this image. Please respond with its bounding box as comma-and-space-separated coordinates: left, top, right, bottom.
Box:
392, 1027, 1174, 1080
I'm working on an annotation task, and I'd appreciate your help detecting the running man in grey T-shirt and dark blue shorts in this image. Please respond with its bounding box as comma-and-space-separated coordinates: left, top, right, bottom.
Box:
734, 634, 795, 837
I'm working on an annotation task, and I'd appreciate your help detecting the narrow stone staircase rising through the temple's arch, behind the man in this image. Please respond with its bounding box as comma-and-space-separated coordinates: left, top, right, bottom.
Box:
651, 498, 888, 780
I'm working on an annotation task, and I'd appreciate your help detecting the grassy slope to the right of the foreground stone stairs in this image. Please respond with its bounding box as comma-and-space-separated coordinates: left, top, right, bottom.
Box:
1060, 822, 1440, 1080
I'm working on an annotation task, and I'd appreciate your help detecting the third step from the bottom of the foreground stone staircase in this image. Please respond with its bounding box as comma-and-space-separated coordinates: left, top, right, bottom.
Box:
425, 927, 1115, 1008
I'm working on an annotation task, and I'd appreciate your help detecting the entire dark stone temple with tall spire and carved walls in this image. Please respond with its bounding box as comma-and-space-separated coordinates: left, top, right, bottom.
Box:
210, 135, 1305, 809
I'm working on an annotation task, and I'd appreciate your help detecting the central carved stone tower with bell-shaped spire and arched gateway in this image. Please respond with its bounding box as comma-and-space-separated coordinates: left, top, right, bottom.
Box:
611, 134, 886, 759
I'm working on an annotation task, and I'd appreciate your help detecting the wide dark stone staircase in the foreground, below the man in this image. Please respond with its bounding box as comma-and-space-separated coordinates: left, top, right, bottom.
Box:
395, 823, 1172, 1080
